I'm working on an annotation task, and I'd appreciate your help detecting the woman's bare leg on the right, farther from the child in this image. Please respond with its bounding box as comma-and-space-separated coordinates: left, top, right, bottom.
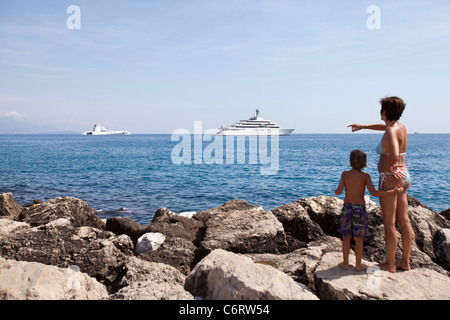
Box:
396, 184, 413, 270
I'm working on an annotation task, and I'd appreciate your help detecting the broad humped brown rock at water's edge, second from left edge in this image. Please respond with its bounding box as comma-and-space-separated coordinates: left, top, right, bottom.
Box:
18, 197, 105, 229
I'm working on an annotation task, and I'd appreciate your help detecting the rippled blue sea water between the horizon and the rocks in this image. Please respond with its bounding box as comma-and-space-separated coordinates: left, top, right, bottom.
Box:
0, 134, 450, 224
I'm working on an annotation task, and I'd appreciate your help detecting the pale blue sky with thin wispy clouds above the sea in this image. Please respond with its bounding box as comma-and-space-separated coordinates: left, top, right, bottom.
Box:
0, 0, 450, 133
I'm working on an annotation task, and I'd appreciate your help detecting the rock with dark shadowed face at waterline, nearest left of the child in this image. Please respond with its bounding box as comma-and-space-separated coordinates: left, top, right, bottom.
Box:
272, 201, 324, 251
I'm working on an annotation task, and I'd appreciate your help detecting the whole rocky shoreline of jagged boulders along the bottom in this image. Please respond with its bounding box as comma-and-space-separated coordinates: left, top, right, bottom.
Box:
0, 193, 450, 300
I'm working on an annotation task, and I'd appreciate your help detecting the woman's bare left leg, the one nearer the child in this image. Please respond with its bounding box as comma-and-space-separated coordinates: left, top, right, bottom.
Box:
379, 195, 398, 272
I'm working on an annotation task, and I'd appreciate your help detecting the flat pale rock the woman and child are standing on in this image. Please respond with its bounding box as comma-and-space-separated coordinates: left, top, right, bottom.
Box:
315, 252, 450, 300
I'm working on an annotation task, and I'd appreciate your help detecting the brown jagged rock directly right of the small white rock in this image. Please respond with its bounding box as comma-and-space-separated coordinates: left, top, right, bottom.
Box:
139, 237, 197, 275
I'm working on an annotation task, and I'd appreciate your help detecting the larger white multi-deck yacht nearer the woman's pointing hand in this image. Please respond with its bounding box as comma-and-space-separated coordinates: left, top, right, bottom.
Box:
215, 109, 294, 136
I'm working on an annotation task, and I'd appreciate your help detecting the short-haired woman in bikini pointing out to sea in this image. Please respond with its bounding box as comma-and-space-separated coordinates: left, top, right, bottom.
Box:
349, 97, 412, 272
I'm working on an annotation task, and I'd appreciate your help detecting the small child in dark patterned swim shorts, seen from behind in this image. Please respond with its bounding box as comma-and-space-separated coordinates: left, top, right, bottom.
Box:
334, 150, 403, 271
